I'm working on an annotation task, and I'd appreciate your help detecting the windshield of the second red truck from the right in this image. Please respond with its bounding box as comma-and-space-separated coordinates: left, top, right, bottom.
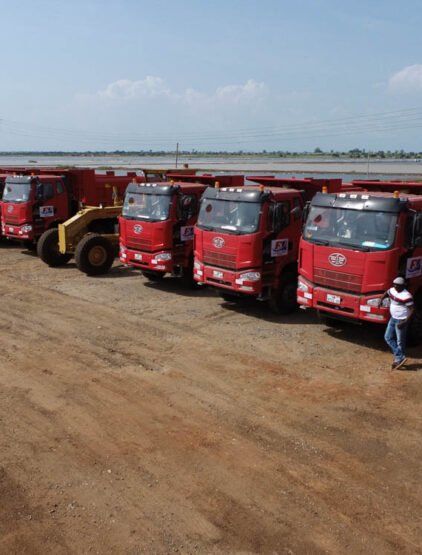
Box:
197, 199, 261, 234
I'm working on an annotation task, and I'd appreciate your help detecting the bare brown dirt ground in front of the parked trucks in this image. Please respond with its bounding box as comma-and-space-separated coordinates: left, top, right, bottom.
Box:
0, 245, 422, 555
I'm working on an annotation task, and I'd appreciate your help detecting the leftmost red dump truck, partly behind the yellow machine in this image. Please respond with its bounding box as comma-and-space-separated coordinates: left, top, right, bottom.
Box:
1, 168, 141, 244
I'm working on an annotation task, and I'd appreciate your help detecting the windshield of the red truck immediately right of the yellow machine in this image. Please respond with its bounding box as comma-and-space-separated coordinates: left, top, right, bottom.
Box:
122, 193, 171, 222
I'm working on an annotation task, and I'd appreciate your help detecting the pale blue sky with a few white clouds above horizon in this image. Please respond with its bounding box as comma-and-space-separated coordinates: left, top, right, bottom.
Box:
0, 0, 422, 152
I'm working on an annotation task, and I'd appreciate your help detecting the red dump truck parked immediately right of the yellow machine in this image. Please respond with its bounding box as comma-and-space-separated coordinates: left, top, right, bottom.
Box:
119, 173, 244, 284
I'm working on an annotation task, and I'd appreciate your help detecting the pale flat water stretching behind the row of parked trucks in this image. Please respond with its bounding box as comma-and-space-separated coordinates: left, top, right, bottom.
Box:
0, 154, 422, 180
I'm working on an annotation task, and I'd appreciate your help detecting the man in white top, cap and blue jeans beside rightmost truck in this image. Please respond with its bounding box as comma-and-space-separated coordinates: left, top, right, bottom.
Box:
380, 277, 413, 370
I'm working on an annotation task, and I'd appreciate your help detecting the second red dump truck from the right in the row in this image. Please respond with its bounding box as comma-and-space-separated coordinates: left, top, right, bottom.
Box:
194, 177, 342, 312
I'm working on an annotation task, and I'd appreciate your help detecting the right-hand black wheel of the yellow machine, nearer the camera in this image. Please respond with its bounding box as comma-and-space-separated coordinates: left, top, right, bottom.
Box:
75, 233, 114, 276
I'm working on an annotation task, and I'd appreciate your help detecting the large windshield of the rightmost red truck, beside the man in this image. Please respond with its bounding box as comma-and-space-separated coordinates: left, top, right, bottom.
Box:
303, 206, 397, 250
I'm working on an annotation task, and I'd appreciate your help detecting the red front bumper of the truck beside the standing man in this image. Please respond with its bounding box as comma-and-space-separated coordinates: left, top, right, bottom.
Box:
297, 280, 390, 324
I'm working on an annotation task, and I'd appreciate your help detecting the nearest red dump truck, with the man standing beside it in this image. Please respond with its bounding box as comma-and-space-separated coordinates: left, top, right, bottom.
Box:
297, 181, 422, 342
